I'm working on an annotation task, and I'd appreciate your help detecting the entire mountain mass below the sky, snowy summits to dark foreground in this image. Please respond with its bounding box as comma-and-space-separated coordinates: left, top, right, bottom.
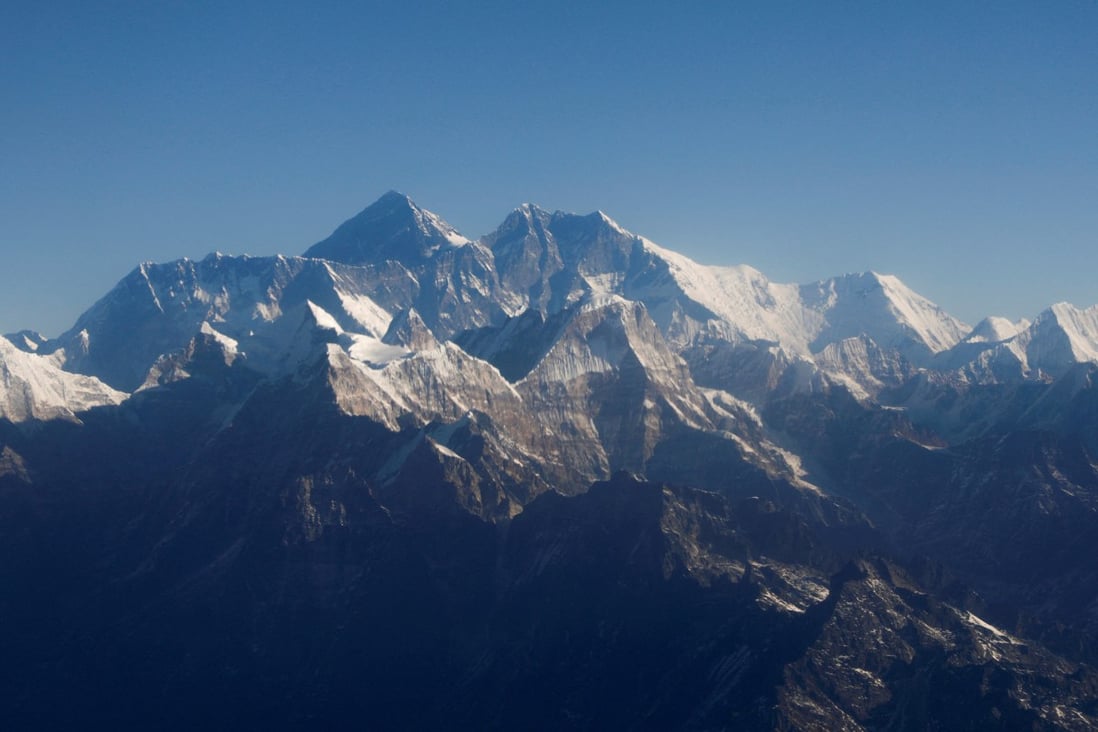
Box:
0, 193, 1098, 730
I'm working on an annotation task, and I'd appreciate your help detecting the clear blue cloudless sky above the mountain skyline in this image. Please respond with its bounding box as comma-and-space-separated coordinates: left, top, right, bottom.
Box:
0, 0, 1098, 336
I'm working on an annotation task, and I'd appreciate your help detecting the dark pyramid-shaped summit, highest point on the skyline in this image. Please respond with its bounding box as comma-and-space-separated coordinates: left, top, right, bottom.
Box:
305, 191, 469, 268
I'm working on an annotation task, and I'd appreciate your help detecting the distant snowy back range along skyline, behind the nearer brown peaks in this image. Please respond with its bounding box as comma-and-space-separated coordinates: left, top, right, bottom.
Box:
0, 192, 1098, 419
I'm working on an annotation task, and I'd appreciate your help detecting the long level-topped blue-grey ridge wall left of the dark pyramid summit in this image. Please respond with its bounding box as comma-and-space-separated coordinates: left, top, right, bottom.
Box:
50, 255, 411, 391
